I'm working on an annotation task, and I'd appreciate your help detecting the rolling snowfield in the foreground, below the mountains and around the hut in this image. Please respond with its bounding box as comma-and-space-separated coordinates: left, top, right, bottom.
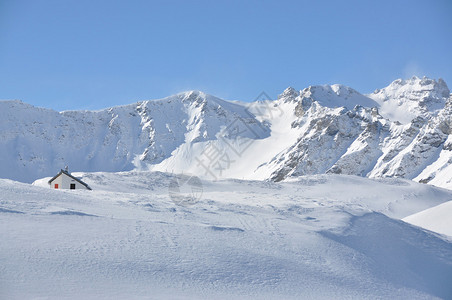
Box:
0, 172, 452, 299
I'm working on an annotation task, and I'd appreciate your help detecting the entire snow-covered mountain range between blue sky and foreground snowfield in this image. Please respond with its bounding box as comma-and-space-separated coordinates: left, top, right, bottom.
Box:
0, 77, 452, 188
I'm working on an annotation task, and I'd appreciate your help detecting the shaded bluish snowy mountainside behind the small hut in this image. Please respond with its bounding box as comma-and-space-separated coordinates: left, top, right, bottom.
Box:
0, 92, 268, 182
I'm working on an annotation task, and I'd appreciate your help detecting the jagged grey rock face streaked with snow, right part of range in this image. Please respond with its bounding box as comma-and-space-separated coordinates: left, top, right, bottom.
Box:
269, 78, 452, 190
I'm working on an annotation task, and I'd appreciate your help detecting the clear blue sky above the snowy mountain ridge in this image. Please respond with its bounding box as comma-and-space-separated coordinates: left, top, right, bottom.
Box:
0, 0, 452, 110
